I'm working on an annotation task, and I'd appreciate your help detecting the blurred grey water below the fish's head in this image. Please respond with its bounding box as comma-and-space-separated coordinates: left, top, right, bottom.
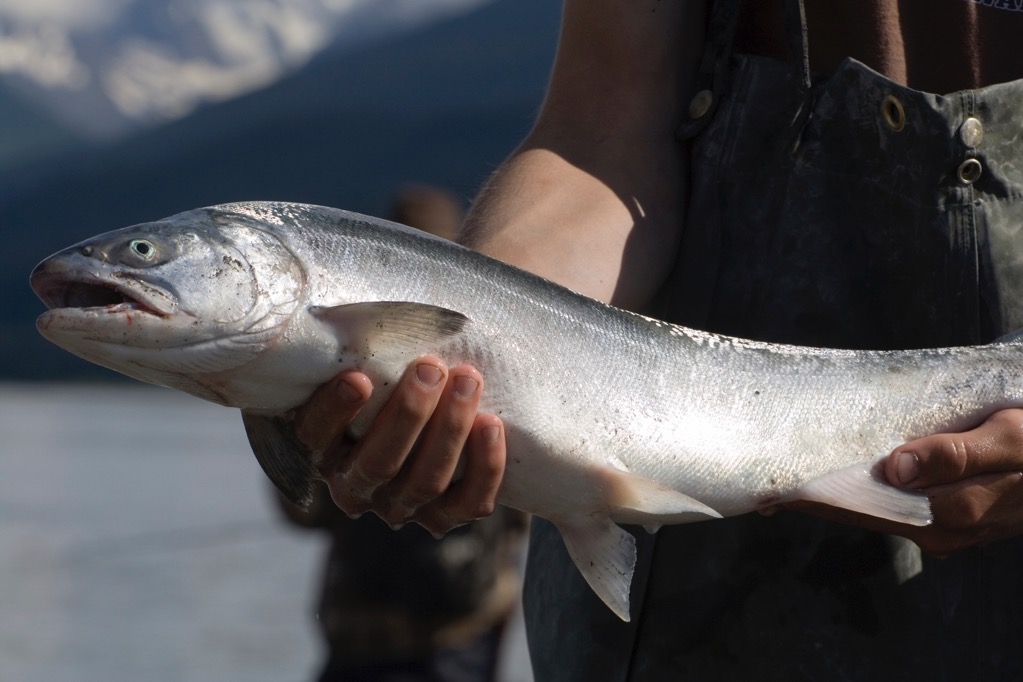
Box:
0, 384, 530, 682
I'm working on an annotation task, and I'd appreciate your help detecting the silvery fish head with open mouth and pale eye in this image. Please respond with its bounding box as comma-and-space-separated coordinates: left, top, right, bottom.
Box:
31, 209, 306, 403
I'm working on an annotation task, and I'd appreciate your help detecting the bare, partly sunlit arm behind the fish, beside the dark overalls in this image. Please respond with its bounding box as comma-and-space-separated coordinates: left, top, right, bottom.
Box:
461, 0, 703, 309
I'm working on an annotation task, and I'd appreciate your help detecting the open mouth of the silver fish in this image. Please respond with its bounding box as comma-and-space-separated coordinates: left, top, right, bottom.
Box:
32, 271, 177, 317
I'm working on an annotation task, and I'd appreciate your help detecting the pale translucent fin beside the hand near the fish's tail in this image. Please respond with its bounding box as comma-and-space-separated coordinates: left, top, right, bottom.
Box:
793, 464, 933, 526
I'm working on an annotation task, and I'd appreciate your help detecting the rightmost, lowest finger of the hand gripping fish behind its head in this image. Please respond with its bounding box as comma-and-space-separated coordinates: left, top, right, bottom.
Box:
416, 414, 507, 536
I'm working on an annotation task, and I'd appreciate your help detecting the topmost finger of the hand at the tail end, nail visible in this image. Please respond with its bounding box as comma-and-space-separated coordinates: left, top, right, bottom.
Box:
885, 409, 1023, 488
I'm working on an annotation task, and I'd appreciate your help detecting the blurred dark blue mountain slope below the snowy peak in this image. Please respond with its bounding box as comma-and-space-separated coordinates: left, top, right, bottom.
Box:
0, 0, 560, 378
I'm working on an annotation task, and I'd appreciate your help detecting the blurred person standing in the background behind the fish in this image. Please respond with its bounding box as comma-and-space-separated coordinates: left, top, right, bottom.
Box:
278, 185, 526, 682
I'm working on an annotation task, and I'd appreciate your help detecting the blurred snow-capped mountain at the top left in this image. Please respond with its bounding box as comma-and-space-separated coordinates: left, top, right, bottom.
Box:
0, 0, 490, 139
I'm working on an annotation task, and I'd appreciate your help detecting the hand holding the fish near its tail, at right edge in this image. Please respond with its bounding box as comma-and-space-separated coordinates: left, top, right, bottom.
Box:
785, 409, 1023, 556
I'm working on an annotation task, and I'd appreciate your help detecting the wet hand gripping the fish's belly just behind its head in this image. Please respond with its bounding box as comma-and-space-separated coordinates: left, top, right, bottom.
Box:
296, 356, 505, 535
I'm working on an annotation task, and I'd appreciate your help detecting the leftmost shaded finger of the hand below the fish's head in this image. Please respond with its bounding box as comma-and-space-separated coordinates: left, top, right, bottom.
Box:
295, 371, 373, 452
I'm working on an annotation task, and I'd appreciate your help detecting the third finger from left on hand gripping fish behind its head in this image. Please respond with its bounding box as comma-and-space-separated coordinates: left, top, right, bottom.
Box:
385, 365, 483, 526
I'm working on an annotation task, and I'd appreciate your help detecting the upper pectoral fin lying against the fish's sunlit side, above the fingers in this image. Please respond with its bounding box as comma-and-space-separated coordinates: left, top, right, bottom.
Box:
309, 301, 469, 359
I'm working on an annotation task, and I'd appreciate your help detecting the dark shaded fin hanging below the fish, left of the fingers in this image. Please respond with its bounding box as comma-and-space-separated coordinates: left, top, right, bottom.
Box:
241, 410, 315, 509
